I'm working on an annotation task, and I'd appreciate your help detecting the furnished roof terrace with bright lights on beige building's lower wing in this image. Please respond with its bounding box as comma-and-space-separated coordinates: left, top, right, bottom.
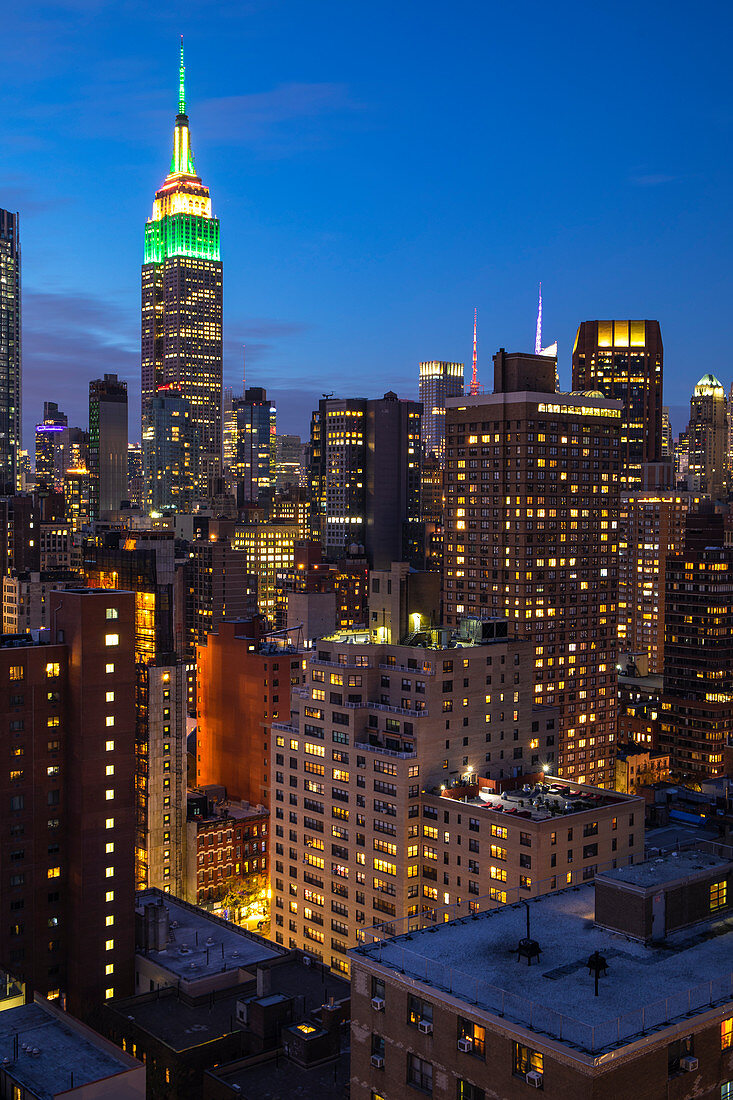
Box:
444, 777, 633, 821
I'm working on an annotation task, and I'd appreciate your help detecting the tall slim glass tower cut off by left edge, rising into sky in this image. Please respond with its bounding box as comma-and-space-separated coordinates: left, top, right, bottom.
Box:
0, 210, 22, 493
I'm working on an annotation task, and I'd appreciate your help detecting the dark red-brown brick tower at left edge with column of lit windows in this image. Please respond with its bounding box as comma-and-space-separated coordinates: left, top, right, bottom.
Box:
0, 589, 135, 1016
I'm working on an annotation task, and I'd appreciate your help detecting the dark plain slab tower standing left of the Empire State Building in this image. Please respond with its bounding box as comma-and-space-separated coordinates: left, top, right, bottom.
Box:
89, 374, 128, 519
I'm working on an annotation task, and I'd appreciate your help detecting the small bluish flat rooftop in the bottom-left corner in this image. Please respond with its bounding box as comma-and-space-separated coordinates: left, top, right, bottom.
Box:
0, 1004, 135, 1100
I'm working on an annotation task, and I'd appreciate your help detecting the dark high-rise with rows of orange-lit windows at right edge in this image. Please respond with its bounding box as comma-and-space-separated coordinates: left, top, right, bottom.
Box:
659, 505, 733, 780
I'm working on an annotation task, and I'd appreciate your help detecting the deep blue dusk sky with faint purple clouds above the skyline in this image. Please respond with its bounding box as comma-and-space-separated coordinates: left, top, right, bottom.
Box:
0, 0, 733, 449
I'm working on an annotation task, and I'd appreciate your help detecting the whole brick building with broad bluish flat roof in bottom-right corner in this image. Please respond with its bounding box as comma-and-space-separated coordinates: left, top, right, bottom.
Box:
350, 849, 733, 1100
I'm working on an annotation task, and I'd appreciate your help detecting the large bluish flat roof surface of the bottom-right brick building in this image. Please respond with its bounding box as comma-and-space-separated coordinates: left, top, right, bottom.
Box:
351, 883, 733, 1054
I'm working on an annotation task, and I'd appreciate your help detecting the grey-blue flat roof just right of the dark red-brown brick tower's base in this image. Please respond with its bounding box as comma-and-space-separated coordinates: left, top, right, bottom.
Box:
136, 890, 278, 981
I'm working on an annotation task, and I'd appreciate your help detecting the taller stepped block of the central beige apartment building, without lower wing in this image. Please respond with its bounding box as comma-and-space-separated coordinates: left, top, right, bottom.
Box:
270, 620, 557, 970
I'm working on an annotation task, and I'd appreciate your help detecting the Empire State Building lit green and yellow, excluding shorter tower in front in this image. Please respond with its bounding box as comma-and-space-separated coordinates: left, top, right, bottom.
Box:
142, 40, 222, 498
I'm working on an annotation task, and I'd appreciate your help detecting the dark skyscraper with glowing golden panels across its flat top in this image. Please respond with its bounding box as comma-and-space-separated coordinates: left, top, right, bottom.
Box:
572, 320, 664, 490
